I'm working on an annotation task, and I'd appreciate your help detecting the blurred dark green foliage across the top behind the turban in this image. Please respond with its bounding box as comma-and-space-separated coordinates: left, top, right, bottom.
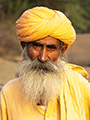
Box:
0, 0, 90, 33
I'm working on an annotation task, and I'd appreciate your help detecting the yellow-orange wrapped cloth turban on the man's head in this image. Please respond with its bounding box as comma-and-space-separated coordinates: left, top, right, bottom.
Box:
16, 7, 76, 47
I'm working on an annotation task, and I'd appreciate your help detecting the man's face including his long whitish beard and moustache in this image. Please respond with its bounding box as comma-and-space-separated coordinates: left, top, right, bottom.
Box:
18, 37, 67, 105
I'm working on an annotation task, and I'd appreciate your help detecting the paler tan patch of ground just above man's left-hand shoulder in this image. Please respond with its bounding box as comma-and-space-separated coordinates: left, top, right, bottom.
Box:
0, 58, 17, 84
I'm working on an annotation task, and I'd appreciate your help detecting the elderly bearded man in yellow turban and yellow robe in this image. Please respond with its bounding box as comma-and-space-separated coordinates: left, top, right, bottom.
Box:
0, 7, 90, 120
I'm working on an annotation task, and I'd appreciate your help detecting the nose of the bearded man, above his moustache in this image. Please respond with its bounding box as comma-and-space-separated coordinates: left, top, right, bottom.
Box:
38, 47, 48, 62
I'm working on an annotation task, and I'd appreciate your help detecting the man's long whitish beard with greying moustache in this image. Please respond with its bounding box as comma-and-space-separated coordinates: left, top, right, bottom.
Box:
18, 48, 64, 105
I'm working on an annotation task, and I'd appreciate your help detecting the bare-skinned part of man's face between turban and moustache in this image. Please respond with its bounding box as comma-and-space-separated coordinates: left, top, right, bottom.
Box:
27, 36, 60, 63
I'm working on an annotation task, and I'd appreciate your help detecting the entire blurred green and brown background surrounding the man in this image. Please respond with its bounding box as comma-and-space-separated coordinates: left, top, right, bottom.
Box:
0, 0, 90, 86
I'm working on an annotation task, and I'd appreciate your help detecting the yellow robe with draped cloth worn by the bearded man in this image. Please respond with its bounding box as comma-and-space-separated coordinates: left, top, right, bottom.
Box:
0, 64, 90, 120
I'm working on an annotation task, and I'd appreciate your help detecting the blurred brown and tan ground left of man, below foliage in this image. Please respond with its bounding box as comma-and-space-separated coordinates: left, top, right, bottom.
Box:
0, 22, 21, 89
